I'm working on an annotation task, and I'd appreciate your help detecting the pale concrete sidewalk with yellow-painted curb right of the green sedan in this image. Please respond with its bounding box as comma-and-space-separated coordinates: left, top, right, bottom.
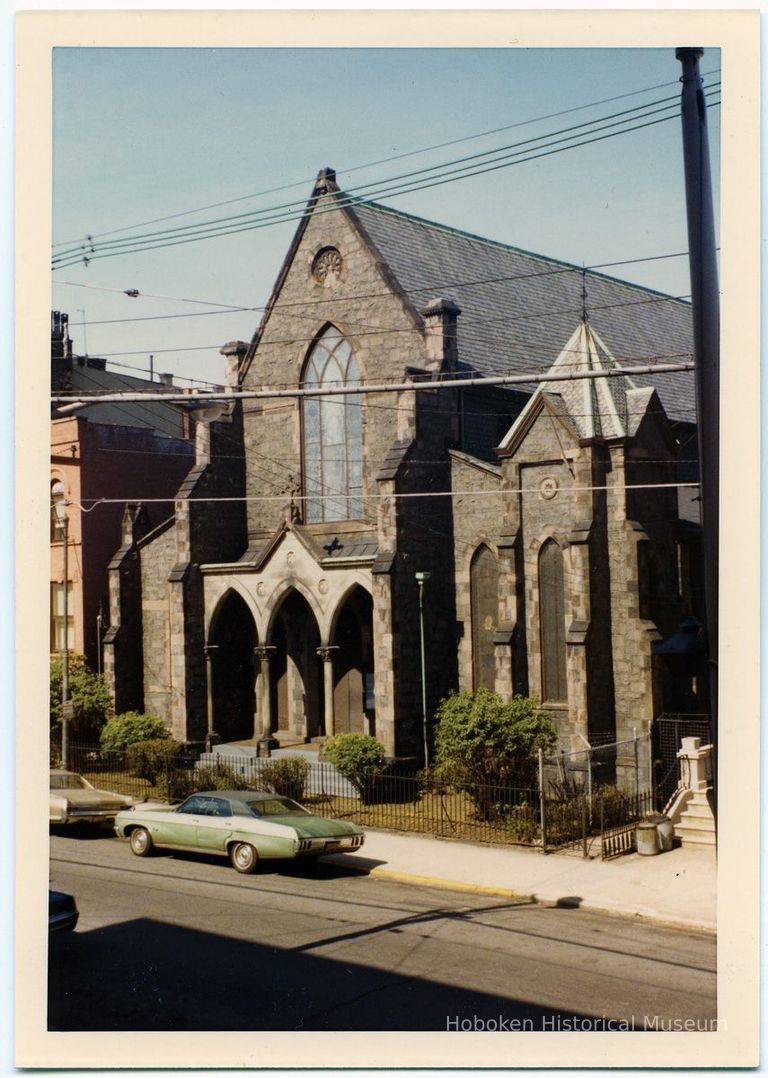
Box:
325, 830, 717, 931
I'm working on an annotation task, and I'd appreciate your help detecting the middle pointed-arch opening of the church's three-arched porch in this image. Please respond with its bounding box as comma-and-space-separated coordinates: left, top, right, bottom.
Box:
270, 591, 324, 741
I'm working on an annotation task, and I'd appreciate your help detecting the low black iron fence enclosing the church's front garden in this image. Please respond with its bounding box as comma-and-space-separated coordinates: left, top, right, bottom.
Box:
58, 744, 653, 856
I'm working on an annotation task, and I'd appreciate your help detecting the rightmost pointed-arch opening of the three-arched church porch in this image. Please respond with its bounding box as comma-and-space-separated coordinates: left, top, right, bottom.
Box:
332, 586, 375, 734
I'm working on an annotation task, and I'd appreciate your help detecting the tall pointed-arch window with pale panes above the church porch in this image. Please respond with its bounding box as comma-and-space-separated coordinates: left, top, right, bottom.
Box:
302, 326, 362, 522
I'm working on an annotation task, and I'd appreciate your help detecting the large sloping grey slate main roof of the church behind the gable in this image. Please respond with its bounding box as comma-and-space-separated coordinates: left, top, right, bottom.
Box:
353, 203, 696, 421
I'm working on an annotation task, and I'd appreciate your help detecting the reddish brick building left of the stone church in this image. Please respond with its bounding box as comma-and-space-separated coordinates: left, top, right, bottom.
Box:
50, 310, 194, 669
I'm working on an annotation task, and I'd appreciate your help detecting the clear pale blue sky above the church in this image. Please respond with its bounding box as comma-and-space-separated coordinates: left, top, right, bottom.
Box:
52, 47, 719, 392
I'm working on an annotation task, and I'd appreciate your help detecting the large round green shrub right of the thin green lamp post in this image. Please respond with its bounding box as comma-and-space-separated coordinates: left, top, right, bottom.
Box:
435, 689, 557, 819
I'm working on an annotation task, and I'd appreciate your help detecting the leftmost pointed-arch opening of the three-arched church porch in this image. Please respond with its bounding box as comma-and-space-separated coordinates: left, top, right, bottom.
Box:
208, 592, 257, 742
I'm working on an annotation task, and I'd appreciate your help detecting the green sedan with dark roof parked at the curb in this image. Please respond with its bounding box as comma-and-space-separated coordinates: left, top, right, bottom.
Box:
114, 790, 365, 873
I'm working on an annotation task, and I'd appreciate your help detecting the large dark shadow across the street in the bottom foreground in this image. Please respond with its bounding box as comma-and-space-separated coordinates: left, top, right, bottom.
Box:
49, 914, 604, 1032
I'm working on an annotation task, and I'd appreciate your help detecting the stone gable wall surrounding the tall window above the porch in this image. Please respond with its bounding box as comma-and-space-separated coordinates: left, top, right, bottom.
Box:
238, 189, 426, 537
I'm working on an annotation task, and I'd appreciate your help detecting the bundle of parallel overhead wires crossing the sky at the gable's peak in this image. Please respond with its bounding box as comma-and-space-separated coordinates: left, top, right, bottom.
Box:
54, 93, 719, 268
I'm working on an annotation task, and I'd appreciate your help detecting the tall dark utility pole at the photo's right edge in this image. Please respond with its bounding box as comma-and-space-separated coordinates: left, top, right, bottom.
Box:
675, 47, 719, 803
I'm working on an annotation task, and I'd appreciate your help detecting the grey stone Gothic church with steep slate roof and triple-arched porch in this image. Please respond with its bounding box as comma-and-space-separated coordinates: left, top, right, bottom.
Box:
105, 169, 701, 756
